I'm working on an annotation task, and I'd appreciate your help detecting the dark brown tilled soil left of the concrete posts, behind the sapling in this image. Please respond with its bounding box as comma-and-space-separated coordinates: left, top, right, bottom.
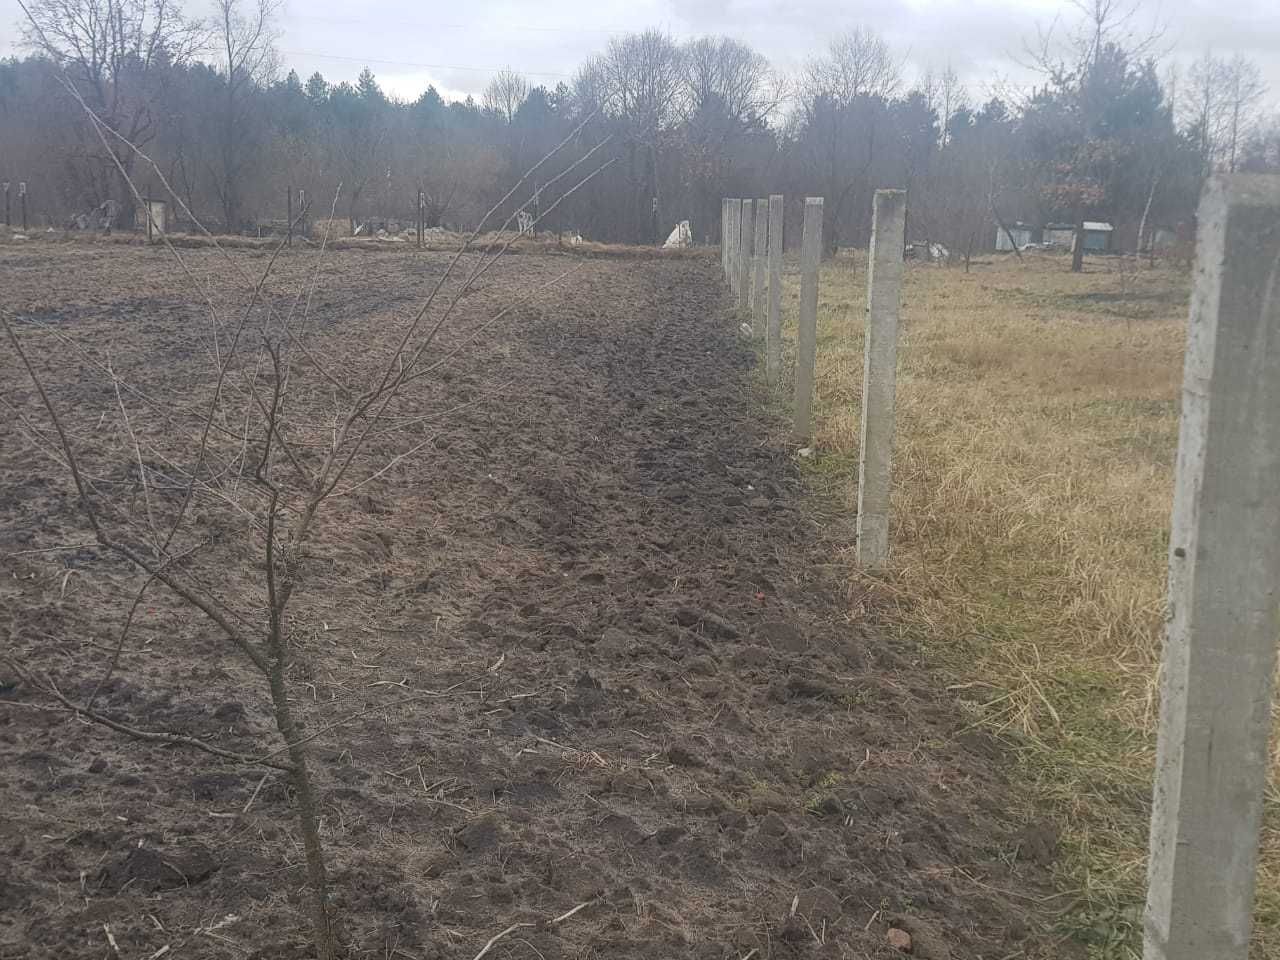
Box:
0, 246, 1061, 960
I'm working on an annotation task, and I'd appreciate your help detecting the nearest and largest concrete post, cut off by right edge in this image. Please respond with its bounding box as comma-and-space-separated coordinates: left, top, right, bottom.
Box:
1143, 175, 1280, 960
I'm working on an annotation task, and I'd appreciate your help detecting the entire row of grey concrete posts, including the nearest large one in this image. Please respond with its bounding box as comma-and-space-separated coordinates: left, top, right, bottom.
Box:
722, 174, 1280, 960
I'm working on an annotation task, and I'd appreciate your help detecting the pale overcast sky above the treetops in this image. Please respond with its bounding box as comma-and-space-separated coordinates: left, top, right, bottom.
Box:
0, 0, 1280, 109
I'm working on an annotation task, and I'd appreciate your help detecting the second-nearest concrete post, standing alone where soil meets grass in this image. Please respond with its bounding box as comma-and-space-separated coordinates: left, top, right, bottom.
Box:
858, 189, 906, 570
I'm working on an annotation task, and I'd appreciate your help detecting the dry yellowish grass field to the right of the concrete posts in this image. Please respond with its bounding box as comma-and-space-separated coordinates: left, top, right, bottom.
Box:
783, 255, 1280, 957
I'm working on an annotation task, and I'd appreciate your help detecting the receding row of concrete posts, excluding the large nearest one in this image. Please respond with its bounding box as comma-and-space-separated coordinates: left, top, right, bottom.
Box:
721, 189, 906, 570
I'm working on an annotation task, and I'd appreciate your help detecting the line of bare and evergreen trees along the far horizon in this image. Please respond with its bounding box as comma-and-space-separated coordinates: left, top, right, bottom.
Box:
0, 0, 1280, 251
